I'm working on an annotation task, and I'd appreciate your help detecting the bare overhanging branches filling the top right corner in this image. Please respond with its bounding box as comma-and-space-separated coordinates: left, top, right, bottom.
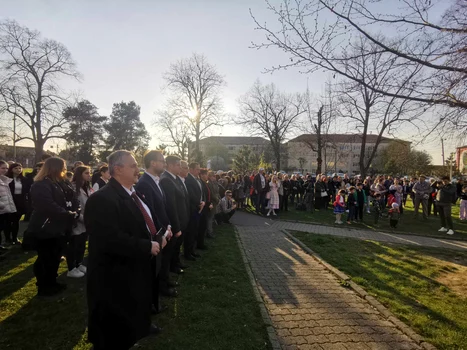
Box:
252, 0, 467, 130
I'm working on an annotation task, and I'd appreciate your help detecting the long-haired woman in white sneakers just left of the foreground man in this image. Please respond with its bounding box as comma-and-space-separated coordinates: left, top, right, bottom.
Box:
66, 165, 94, 278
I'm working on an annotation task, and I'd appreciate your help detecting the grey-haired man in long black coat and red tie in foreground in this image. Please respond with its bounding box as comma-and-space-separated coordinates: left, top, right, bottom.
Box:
84, 151, 165, 350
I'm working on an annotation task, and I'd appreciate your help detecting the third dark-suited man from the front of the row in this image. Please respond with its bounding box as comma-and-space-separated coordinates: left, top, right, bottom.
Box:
160, 156, 188, 274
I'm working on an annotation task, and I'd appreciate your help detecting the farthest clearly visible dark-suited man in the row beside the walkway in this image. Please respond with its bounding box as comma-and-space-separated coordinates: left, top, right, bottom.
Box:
184, 163, 205, 260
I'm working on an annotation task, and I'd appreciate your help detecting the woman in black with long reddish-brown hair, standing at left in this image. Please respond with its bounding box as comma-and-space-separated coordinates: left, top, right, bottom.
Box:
28, 157, 79, 296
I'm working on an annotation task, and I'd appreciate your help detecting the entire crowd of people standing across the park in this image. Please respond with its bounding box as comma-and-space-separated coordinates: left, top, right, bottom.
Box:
0, 150, 467, 350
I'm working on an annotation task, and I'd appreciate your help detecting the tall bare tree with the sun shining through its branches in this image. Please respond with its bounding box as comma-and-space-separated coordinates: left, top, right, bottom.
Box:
164, 54, 225, 161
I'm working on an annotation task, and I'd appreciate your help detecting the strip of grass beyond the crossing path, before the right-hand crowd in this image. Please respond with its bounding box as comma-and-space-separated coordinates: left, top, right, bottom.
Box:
270, 199, 467, 240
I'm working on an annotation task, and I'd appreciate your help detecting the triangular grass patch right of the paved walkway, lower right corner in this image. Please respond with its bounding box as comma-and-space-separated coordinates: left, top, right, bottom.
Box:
292, 232, 467, 350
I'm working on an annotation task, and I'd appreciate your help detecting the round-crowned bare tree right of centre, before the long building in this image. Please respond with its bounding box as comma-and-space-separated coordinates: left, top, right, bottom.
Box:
235, 80, 307, 170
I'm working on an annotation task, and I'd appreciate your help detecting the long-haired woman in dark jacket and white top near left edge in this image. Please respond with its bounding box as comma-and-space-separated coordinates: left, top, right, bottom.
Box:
6, 163, 31, 244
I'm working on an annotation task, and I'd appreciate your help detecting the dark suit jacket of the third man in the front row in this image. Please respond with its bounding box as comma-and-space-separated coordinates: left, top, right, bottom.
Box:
160, 172, 189, 234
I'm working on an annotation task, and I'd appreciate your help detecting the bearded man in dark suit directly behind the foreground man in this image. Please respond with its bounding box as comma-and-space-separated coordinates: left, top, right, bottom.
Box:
135, 151, 177, 300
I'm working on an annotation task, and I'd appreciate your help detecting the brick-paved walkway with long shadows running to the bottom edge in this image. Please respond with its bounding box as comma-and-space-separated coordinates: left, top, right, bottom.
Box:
232, 213, 436, 350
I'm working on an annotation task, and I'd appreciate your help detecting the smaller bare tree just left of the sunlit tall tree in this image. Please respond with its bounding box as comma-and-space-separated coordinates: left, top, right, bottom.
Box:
153, 110, 190, 159
